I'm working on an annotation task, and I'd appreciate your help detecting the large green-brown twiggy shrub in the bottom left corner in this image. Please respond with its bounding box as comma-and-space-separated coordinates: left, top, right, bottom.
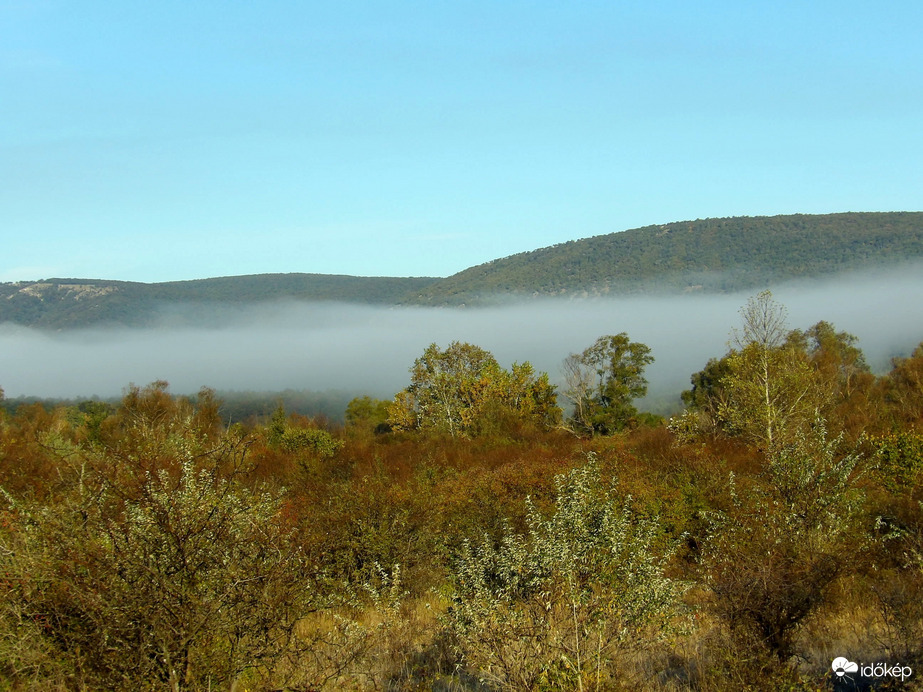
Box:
0, 436, 322, 689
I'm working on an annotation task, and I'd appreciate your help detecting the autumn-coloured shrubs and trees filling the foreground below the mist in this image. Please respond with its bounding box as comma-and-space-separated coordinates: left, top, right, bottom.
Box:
0, 294, 923, 692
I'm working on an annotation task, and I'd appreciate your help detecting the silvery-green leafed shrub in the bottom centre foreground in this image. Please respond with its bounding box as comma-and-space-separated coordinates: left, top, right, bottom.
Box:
448, 460, 682, 690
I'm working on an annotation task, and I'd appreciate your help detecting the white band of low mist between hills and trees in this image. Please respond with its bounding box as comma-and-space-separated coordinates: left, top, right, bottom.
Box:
0, 271, 923, 412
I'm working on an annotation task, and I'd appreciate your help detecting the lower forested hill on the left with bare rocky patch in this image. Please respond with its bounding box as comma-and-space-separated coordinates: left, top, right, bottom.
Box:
0, 274, 438, 329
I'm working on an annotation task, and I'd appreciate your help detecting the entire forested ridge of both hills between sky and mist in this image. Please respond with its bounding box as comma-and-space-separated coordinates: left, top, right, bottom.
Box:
0, 212, 923, 329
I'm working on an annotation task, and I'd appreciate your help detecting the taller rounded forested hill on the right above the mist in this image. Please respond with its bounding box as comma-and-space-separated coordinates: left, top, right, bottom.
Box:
412, 212, 923, 305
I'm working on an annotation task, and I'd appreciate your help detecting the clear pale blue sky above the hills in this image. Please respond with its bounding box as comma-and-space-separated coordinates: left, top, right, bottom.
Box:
0, 0, 923, 281
